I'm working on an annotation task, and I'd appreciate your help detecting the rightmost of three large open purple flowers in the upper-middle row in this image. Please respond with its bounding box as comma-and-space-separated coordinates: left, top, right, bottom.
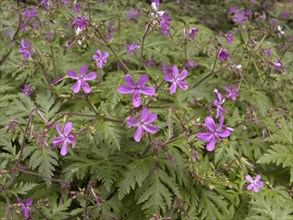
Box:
164, 65, 188, 94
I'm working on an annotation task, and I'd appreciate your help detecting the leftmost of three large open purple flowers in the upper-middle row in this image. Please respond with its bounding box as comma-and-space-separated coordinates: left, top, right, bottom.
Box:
66, 65, 97, 93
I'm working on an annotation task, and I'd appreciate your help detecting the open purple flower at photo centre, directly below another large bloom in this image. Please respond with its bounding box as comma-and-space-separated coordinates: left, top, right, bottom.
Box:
127, 108, 159, 142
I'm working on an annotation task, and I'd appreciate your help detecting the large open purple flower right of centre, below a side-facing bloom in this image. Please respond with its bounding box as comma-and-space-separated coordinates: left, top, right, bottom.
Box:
197, 116, 233, 151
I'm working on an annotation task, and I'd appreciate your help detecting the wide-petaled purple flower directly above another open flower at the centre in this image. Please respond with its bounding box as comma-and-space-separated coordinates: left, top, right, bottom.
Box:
118, 74, 156, 108
